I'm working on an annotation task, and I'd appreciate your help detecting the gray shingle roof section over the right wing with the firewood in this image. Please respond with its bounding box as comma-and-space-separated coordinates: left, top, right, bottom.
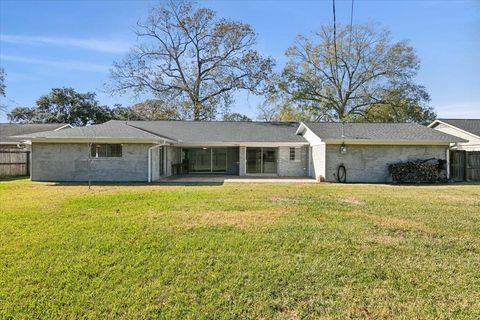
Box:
305, 122, 463, 142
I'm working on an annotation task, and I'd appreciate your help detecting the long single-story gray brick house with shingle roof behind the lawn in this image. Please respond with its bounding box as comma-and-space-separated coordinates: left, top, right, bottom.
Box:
16, 121, 464, 182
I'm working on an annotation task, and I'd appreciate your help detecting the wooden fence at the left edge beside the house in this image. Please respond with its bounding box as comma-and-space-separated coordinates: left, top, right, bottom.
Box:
0, 150, 30, 177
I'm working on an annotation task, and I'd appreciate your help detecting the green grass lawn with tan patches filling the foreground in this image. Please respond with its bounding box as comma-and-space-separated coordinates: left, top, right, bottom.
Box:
0, 180, 480, 319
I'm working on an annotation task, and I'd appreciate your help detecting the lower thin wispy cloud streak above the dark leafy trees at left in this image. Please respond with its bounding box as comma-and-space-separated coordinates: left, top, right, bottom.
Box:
0, 55, 110, 72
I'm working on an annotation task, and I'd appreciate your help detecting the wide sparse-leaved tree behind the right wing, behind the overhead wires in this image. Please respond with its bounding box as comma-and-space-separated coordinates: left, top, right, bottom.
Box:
278, 25, 434, 121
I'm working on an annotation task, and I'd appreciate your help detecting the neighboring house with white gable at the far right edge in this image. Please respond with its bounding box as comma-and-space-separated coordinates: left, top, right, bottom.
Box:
428, 119, 480, 151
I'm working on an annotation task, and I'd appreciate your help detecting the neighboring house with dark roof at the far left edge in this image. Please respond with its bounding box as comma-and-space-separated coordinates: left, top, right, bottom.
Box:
0, 123, 71, 150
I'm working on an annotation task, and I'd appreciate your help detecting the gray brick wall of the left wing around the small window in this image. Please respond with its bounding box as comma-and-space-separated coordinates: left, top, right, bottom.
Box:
31, 143, 152, 182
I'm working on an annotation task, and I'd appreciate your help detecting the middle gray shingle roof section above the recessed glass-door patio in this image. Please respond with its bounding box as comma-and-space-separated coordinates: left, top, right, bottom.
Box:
128, 121, 306, 143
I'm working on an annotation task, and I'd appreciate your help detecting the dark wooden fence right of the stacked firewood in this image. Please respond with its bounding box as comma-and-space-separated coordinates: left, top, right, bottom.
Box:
450, 151, 480, 181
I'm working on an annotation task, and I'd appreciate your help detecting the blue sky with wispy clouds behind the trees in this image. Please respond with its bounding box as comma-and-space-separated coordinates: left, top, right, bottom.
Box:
0, 0, 480, 122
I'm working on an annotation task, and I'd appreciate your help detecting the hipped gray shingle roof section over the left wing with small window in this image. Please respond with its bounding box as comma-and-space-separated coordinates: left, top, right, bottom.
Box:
15, 121, 163, 141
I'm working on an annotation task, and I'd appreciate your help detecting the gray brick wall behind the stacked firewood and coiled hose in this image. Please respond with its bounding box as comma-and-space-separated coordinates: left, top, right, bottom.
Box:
326, 145, 448, 182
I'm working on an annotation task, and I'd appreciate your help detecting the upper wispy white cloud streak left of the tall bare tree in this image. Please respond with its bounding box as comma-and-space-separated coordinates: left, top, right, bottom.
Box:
0, 34, 129, 53
